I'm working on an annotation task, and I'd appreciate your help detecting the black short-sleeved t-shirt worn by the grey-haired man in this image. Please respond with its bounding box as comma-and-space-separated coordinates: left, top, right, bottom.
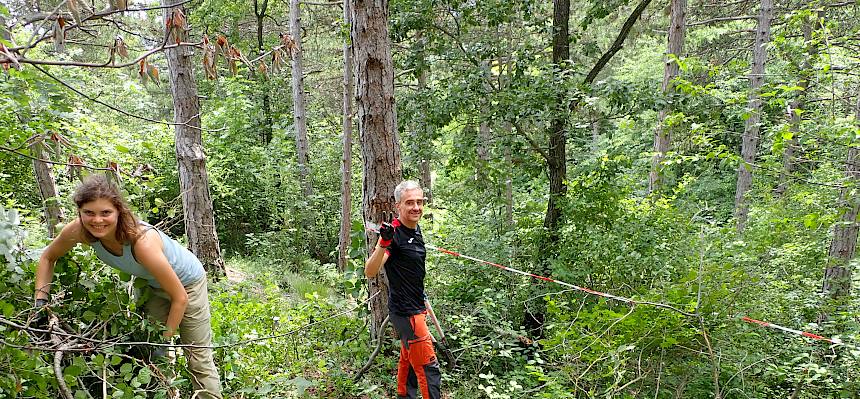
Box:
385, 220, 427, 316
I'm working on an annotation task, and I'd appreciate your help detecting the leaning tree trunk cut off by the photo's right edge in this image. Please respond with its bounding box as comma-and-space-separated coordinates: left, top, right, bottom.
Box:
823, 96, 860, 299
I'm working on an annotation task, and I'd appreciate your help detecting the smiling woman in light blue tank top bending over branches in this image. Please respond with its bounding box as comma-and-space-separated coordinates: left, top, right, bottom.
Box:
36, 174, 221, 399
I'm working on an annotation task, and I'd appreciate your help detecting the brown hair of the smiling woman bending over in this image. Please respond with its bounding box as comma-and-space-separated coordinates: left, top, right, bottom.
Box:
72, 173, 140, 244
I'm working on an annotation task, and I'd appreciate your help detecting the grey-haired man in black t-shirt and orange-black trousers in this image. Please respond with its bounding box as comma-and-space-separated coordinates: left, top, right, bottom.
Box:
364, 180, 442, 399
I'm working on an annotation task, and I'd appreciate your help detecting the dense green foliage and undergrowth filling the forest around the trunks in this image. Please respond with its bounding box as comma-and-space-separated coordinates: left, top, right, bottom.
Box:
0, 0, 860, 398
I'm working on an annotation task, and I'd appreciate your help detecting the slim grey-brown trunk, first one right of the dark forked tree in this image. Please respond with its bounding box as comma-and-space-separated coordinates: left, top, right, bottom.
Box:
648, 0, 687, 193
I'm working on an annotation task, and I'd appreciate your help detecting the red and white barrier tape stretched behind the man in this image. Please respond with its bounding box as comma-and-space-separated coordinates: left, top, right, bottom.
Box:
366, 222, 860, 349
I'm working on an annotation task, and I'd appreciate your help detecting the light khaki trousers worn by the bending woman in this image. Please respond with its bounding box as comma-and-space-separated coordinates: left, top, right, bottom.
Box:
145, 276, 222, 399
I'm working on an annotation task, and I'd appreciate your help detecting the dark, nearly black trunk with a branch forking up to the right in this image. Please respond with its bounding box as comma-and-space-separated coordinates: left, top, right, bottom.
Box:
544, 0, 570, 234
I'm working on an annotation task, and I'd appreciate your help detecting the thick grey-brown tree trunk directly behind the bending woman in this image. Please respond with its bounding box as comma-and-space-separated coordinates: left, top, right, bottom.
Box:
164, 0, 224, 276
